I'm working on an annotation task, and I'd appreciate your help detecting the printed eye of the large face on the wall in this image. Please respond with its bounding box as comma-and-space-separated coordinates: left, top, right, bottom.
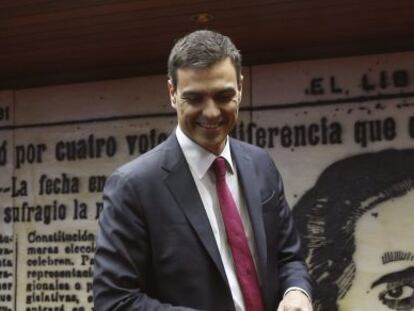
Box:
379, 281, 414, 310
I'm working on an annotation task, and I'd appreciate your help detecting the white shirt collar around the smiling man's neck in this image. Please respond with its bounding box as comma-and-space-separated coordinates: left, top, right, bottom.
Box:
175, 125, 234, 179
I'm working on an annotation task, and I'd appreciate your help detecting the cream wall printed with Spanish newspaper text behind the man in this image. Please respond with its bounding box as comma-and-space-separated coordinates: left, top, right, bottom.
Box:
0, 52, 414, 310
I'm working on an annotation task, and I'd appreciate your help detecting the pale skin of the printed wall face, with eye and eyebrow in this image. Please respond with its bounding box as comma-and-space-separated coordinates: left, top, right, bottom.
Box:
339, 191, 414, 311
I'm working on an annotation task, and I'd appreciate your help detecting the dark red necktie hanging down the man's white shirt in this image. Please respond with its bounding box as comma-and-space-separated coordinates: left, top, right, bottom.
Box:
213, 157, 264, 311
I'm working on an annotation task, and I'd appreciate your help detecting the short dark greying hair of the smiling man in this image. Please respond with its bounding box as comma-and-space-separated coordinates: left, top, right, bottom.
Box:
168, 30, 241, 87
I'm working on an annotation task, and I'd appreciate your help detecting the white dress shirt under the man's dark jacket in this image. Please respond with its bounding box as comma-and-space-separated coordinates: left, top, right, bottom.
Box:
176, 126, 260, 311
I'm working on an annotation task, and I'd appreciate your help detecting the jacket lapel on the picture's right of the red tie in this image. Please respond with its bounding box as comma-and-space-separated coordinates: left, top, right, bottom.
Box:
230, 140, 267, 286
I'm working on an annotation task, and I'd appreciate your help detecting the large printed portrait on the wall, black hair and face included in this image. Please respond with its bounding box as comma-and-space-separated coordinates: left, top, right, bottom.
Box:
293, 149, 414, 311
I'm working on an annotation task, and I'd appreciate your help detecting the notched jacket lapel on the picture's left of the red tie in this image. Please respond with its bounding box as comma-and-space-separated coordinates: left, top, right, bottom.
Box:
163, 135, 227, 283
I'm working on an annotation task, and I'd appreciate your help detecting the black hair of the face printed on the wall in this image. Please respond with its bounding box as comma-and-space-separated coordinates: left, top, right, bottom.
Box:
293, 149, 414, 311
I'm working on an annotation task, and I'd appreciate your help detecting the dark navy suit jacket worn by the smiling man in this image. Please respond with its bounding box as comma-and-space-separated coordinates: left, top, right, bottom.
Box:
93, 135, 311, 311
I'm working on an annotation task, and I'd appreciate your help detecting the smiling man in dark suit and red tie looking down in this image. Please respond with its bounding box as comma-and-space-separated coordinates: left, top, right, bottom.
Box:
94, 31, 312, 311
